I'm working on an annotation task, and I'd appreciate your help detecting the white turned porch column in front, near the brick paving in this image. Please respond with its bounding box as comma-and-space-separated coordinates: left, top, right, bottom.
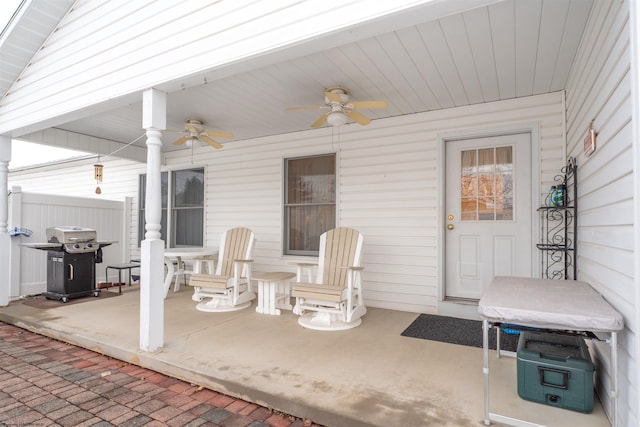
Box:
140, 89, 167, 352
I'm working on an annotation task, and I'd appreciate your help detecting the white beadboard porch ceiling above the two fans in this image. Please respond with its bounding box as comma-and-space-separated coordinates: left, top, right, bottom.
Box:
0, 0, 593, 159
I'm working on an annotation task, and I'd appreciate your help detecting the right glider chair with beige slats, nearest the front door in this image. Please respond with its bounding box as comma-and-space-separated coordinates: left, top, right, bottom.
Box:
291, 228, 367, 331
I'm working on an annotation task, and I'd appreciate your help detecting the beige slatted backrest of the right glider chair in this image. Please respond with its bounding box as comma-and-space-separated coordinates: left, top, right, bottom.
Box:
322, 227, 360, 287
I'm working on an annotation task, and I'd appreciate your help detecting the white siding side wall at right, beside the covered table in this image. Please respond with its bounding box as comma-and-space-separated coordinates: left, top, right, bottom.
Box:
567, 1, 640, 426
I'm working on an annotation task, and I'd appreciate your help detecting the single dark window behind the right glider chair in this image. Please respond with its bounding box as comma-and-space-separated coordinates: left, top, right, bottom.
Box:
283, 154, 336, 256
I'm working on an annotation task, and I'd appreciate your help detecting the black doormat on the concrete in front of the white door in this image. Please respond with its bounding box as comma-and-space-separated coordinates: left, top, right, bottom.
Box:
401, 314, 519, 351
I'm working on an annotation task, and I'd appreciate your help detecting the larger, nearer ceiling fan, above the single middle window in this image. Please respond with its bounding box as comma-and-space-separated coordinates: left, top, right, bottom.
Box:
287, 86, 387, 128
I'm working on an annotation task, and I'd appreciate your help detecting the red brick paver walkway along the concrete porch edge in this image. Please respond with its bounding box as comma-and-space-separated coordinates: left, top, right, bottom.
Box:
0, 322, 321, 427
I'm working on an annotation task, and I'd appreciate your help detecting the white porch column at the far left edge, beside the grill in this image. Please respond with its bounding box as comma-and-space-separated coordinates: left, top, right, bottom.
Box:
0, 135, 11, 306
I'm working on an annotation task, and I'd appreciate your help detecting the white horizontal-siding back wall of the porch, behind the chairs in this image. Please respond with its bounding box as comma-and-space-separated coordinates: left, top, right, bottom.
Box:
9, 92, 564, 313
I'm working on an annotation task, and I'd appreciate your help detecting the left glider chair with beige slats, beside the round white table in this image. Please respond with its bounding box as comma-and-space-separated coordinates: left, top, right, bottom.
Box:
189, 227, 256, 312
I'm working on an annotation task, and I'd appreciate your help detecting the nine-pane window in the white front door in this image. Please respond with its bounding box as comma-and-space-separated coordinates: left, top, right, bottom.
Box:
460, 147, 514, 221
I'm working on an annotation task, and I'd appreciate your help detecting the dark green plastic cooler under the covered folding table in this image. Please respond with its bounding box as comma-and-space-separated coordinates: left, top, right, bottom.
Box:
517, 331, 594, 413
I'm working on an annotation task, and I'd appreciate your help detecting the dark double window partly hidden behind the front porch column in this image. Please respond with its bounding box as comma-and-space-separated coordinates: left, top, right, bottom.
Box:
138, 168, 204, 248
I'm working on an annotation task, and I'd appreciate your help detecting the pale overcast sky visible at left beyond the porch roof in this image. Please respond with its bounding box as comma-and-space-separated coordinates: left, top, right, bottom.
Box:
0, 0, 87, 169
